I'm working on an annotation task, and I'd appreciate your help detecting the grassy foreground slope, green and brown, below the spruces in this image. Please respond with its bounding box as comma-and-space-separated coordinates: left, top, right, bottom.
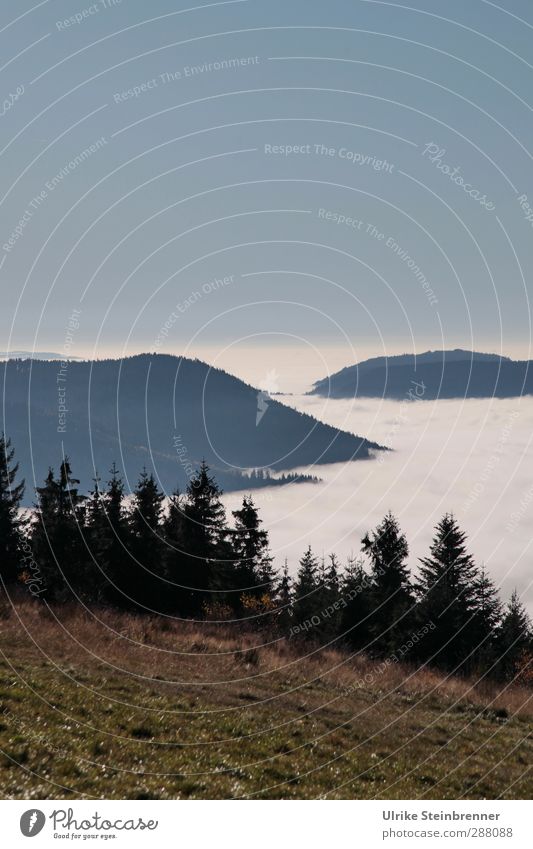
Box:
0, 602, 533, 799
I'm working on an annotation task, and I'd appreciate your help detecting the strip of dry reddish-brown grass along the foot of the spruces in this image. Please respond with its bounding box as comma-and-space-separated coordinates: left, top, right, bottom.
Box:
0, 600, 533, 716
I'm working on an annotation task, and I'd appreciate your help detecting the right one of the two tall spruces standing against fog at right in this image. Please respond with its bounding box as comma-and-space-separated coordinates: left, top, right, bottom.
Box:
417, 513, 479, 670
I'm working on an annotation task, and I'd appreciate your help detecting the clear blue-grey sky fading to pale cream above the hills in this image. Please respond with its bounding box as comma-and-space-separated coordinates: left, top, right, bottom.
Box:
0, 0, 533, 380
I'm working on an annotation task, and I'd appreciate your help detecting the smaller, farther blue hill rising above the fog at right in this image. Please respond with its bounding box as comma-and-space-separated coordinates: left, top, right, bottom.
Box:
310, 349, 533, 400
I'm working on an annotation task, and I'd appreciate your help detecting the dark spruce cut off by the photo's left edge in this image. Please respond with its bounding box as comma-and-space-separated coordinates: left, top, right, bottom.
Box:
0, 434, 24, 584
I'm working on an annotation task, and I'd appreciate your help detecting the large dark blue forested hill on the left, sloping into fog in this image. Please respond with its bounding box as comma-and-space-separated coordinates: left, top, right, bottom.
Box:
0, 354, 380, 501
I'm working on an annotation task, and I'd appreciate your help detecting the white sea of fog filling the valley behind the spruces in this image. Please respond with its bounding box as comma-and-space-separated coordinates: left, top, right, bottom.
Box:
225, 395, 533, 612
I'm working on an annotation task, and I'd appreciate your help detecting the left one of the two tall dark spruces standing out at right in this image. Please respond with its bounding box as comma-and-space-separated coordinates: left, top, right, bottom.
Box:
362, 511, 414, 654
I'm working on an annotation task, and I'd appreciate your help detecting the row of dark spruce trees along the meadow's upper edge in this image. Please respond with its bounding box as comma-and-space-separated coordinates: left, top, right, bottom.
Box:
0, 436, 533, 683
